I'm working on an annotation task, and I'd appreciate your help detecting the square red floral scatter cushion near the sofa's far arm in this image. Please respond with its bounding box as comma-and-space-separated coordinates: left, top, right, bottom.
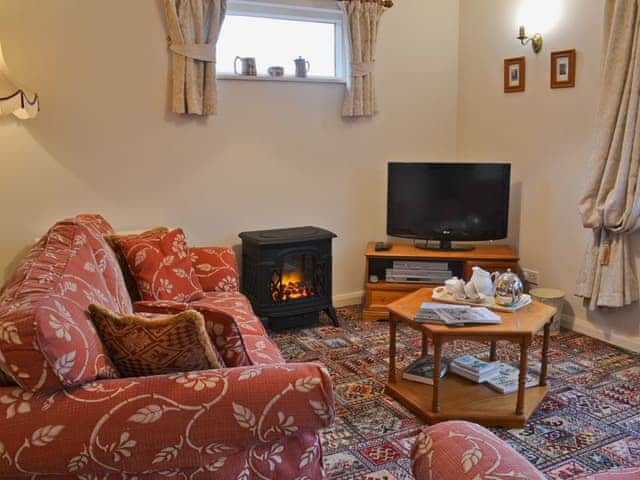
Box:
116, 228, 204, 302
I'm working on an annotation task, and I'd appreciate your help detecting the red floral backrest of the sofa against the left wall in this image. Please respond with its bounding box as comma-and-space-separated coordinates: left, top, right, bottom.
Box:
0, 216, 132, 392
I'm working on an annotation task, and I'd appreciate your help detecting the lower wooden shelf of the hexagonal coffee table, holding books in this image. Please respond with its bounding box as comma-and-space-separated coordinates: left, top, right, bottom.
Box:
385, 371, 549, 428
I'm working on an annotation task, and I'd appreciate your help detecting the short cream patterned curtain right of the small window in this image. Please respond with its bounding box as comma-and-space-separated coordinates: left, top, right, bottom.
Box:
339, 0, 384, 117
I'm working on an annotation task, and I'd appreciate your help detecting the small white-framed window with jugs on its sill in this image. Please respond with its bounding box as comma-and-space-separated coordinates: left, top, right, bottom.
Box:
217, 0, 345, 80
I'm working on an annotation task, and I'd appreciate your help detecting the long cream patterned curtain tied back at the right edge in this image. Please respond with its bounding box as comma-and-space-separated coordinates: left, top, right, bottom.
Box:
576, 0, 640, 308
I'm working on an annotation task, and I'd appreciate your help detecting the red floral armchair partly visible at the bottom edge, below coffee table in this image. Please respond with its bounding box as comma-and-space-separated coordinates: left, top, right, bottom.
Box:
412, 421, 640, 480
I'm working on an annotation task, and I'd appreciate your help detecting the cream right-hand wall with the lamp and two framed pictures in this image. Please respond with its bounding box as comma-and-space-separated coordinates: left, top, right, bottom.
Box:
458, 0, 640, 350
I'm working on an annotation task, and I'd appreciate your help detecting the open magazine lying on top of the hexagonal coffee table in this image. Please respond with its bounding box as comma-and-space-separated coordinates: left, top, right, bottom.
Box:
413, 302, 502, 326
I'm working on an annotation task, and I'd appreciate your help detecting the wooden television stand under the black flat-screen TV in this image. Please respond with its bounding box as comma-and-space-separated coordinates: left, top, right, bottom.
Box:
362, 242, 519, 321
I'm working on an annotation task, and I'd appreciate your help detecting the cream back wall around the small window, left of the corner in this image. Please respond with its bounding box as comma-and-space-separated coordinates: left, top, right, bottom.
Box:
0, 0, 458, 299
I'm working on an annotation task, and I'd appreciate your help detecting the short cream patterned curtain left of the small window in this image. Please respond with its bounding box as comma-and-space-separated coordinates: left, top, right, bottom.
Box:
165, 0, 227, 115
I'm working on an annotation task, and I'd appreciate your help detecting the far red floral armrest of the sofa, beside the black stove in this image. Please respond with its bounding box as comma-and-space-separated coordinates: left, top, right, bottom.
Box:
190, 247, 240, 292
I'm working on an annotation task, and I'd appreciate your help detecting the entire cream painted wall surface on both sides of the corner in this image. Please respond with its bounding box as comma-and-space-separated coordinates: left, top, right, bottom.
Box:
6, 0, 640, 348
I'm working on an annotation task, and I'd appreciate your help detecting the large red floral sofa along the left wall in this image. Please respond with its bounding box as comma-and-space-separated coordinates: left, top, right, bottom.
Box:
0, 215, 334, 480
